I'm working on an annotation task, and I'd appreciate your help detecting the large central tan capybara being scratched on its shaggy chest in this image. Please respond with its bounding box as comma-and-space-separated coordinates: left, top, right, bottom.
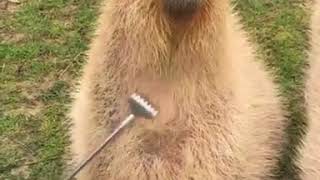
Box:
72, 0, 285, 180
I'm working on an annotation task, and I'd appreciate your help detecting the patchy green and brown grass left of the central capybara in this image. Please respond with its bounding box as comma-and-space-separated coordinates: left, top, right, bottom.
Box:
0, 0, 97, 179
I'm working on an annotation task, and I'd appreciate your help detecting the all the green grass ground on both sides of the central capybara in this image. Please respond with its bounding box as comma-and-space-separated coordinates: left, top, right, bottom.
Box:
0, 0, 309, 179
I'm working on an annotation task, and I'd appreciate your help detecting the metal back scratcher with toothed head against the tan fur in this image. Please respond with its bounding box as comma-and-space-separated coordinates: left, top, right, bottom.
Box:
68, 93, 158, 180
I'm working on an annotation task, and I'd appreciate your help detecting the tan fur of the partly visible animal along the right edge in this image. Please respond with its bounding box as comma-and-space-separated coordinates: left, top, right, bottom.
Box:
298, 0, 320, 180
